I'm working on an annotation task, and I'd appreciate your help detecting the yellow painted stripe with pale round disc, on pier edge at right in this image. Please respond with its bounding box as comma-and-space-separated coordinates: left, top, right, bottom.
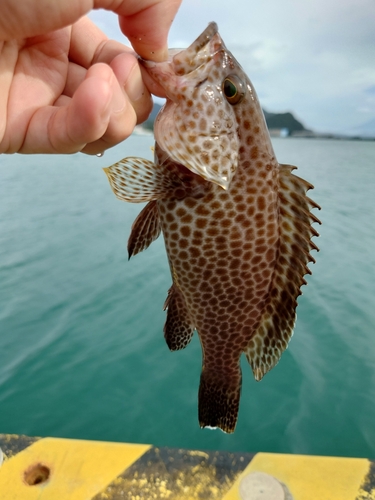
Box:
223, 453, 372, 500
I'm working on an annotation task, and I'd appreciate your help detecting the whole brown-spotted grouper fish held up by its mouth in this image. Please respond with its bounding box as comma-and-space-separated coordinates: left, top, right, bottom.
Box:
104, 23, 320, 433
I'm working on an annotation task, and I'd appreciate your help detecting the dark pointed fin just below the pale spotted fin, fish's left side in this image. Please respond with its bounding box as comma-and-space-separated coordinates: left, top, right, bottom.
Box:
128, 200, 161, 259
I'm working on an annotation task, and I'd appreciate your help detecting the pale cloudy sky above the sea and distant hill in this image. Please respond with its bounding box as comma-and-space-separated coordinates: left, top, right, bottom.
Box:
90, 0, 375, 135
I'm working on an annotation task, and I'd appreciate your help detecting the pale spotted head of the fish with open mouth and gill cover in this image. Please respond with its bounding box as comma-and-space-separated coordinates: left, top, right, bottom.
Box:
143, 23, 262, 189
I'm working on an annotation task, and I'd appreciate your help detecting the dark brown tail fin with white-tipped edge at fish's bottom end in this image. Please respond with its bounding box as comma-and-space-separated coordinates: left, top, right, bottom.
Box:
198, 365, 242, 433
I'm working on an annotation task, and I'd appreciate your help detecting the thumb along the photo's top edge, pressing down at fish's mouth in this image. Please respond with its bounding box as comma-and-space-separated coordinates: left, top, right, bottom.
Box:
0, 0, 181, 61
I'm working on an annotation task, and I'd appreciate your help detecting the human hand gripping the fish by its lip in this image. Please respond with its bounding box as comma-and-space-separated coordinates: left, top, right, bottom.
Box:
0, 0, 181, 154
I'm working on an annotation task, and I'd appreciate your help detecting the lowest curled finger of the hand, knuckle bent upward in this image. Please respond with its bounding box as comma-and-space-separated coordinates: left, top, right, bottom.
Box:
20, 64, 136, 153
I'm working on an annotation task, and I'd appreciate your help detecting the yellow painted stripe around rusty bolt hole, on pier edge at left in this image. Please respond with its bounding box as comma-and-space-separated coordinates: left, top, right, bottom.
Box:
0, 438, 151, 500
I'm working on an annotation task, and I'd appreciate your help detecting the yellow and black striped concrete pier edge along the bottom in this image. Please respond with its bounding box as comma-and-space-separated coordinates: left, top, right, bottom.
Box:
0, 434, 375, 500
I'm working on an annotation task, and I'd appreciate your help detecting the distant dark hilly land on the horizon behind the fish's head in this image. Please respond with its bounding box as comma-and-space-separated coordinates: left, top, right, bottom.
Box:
141, 102, 375, 140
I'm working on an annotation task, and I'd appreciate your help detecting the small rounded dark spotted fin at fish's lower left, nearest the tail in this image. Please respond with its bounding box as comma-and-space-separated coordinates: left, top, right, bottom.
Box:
164, 284, 194, 351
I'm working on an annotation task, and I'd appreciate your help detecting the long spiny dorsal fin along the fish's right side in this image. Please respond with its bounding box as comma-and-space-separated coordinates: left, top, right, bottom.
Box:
245, 165, 320, 380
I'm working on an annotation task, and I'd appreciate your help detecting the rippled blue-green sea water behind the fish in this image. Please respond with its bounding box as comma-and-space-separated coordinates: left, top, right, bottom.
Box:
0, 136, 375, 458
